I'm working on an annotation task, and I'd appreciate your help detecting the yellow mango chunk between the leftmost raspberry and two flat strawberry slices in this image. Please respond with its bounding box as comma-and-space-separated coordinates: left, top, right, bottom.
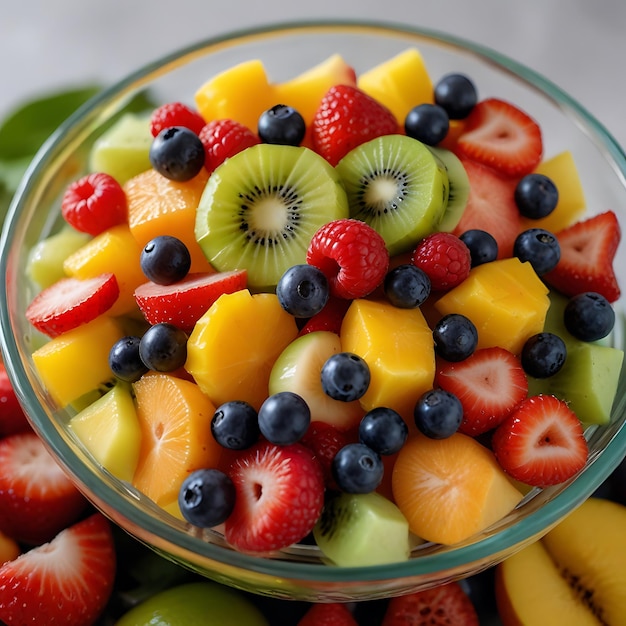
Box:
63, 224, 146, 316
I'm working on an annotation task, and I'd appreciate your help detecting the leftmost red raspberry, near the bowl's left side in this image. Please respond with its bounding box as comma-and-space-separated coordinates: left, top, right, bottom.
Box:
61, 172, 128, 236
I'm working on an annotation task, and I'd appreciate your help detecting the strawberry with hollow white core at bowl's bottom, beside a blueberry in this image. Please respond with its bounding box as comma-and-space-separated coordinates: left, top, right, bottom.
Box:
225, 442, 324, 552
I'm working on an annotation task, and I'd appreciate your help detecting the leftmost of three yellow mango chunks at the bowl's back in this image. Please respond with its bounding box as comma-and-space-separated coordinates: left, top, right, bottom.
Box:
195, 59, 277, 132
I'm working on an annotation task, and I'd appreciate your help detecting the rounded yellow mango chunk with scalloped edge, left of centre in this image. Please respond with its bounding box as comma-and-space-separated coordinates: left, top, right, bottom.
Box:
185, 289, 298, 410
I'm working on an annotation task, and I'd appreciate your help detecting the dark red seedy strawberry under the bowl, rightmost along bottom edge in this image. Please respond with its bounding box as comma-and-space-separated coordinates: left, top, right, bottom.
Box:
382, 582, 480, 626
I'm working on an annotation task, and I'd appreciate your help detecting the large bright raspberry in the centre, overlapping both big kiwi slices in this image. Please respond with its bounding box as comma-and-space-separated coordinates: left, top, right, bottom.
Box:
307, 218, 389, 299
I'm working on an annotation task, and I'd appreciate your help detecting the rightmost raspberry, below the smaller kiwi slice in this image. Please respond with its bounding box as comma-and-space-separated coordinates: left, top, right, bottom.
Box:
412, 233, 471, 291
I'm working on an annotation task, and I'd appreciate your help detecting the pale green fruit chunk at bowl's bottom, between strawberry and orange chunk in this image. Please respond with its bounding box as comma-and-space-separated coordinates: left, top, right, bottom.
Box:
313, 492, 411, 567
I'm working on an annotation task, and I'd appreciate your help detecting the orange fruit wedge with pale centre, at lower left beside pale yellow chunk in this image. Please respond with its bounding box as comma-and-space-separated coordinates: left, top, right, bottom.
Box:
132, 372, 221, 507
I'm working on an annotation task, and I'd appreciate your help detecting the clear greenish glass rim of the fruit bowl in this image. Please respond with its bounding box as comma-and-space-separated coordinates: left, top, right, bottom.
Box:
0, 19, 626, 583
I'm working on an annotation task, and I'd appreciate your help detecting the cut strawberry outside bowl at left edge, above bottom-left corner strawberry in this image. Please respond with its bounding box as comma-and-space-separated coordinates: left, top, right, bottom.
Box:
0, 431, 87, 545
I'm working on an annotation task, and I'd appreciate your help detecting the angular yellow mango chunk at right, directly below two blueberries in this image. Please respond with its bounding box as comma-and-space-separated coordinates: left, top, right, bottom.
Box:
434, 257, 550, 354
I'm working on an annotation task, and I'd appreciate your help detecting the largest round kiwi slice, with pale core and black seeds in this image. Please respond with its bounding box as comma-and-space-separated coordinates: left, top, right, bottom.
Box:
195, 144, 348, 291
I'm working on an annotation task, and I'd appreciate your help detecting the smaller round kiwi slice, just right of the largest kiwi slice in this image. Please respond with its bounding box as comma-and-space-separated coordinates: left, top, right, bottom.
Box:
336, 135, 449, 256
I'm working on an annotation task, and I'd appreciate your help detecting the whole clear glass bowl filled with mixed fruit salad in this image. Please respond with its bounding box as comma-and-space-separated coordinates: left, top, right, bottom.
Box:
0, 22, 626, 601
